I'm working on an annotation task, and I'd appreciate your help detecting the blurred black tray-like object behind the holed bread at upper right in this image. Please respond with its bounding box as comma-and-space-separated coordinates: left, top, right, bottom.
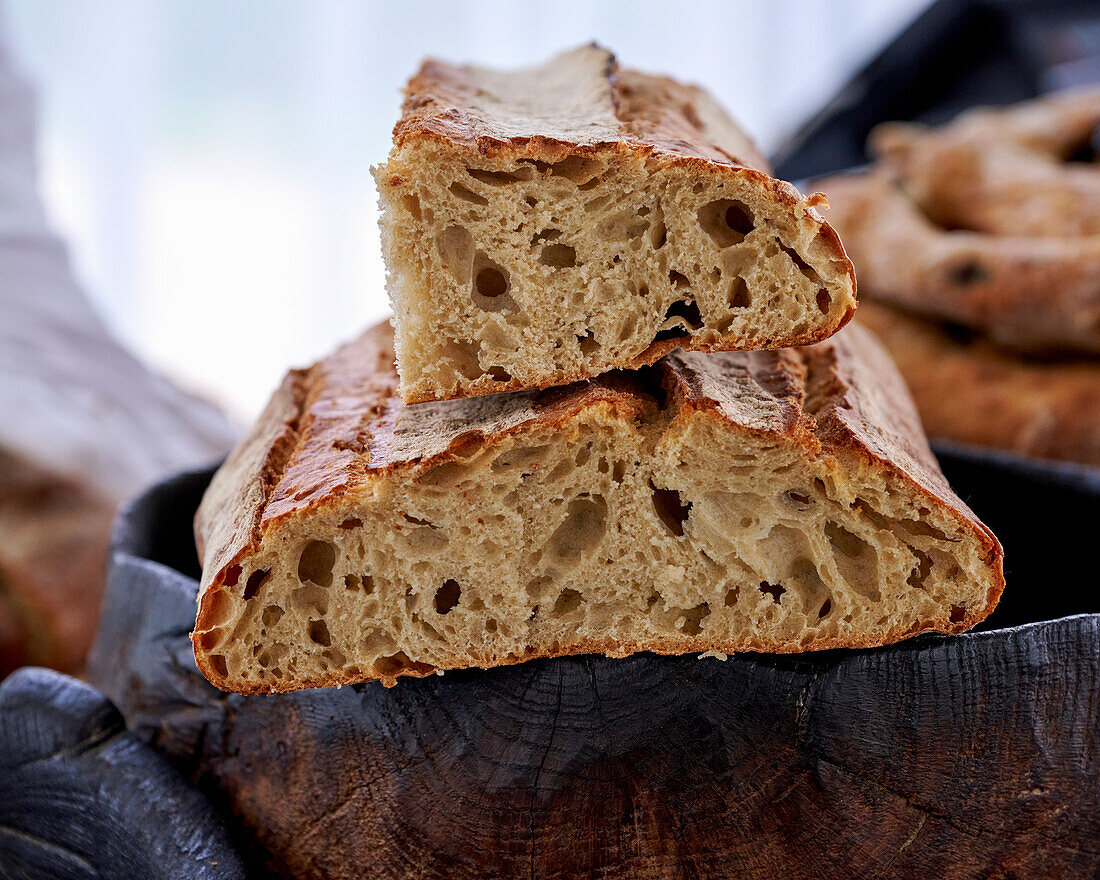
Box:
772, 0, 1100, 180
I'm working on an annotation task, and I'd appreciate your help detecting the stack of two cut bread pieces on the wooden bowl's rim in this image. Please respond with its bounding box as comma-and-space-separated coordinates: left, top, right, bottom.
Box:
193, 46, 1003, 693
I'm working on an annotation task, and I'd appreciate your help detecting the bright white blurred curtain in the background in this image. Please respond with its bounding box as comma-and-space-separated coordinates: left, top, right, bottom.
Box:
7, 0, 926, 416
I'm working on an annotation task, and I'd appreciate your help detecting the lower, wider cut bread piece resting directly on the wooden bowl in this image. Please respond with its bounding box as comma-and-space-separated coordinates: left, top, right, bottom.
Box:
193, 326, 1003, 693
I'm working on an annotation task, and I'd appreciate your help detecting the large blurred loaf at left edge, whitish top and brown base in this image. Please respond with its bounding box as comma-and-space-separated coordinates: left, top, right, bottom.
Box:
0, 41, 235, 678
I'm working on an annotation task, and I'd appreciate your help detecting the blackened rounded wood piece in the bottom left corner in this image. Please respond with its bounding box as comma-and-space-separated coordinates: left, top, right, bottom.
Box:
0, 668, 245, 880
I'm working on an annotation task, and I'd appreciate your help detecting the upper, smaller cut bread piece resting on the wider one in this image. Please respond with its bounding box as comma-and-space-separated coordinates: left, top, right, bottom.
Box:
375, 46, 856, 403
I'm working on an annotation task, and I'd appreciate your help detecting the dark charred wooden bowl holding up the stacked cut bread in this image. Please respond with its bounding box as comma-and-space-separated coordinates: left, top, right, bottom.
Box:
89, 448, 1100, 880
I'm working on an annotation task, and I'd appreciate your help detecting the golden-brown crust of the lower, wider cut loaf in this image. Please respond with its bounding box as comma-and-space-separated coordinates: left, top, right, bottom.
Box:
193, 323, 1003, 692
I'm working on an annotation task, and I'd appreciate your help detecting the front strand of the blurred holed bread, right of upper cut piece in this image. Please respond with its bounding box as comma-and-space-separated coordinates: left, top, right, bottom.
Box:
818, 168, 1100, 354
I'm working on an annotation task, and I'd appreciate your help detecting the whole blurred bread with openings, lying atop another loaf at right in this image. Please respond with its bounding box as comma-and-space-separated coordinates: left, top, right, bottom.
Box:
815, 88, 1100, 355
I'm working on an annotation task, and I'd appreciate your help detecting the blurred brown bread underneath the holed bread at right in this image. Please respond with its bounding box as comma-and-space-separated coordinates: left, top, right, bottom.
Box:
858, 303, 1100, 465
